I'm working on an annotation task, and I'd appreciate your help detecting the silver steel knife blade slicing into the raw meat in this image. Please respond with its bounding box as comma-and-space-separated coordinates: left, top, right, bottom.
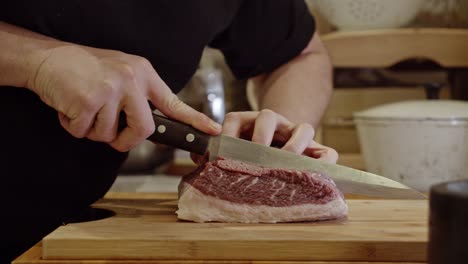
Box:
208, 135, 426, 199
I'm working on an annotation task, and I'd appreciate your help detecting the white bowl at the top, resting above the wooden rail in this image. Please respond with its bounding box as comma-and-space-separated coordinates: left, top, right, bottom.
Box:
313, 0, 424, 30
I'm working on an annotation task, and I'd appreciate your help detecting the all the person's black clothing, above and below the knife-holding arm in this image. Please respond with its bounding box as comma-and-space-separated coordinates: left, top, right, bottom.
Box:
0, 0, 314, 263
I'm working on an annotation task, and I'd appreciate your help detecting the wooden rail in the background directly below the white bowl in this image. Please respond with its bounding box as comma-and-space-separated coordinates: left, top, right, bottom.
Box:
322, 28, 468, 68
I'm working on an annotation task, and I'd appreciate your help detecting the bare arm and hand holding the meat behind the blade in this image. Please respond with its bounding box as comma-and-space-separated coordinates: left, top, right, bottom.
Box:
223, 34, 338, 163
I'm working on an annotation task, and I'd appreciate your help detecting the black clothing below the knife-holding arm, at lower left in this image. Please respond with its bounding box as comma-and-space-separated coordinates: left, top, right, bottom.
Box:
0, 87, 127, 263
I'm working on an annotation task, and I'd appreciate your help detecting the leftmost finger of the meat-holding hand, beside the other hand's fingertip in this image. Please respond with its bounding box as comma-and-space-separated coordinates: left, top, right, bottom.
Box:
222, 112, 258, 137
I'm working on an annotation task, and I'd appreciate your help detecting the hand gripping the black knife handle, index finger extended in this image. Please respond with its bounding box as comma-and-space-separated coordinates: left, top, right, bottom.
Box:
28, 45, 221, 151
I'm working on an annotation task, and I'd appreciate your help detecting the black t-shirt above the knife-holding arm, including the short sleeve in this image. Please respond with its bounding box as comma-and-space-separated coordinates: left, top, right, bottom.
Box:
0, 0, 315, 92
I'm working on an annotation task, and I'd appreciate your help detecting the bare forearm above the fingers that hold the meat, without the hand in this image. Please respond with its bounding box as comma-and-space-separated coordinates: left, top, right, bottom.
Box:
255, 33, 332, 128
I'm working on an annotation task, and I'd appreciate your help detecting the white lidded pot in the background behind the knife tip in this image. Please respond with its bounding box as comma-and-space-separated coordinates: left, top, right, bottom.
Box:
354, 100, 468, 192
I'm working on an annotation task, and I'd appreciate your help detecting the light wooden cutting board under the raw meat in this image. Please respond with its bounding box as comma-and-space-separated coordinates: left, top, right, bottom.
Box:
42, 195, 428, 262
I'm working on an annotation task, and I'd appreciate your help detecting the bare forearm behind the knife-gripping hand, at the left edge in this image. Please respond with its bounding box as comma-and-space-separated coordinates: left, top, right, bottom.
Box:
0, 21, 62, 87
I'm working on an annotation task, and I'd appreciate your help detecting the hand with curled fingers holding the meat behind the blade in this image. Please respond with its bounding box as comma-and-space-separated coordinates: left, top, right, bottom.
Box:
192, 109, 338, 163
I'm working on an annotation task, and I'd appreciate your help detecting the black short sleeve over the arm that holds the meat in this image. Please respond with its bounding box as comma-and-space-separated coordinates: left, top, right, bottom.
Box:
210, 0, 315, 79
